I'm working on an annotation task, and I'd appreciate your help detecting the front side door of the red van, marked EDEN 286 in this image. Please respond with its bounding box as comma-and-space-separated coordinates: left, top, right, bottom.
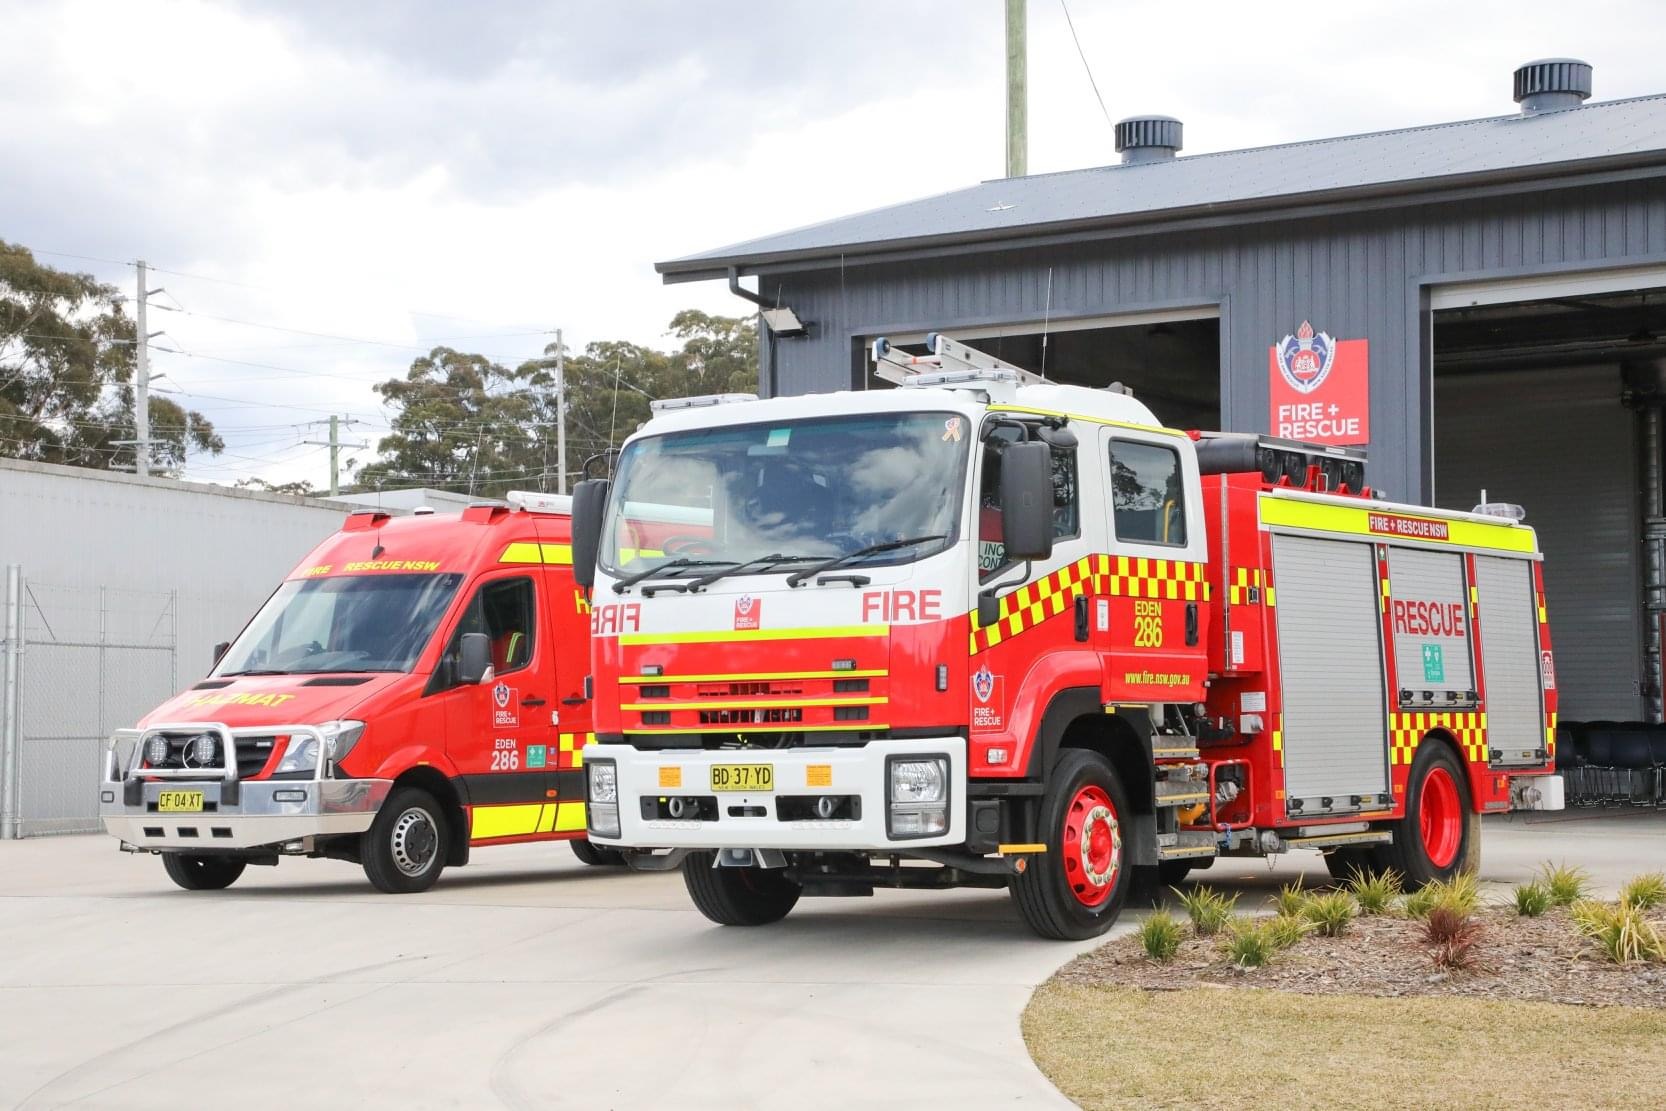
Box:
438, 570, 556, 841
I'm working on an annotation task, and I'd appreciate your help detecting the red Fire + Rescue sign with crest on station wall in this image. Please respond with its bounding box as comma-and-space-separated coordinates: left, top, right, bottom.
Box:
1268, 320, 1371, 445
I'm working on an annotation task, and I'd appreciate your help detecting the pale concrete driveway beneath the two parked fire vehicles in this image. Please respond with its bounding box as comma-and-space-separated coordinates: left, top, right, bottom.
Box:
0, 815, 1666, 1108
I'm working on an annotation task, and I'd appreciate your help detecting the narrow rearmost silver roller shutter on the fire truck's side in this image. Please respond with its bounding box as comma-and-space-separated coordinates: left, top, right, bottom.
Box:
1474, 556, 1544, 765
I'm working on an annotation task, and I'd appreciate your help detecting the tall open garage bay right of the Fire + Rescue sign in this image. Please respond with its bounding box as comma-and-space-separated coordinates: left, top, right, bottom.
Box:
1433, 288, 1666, 723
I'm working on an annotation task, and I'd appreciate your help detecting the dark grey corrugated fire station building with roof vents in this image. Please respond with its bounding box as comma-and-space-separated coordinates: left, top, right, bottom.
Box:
658, 58, 1666, 721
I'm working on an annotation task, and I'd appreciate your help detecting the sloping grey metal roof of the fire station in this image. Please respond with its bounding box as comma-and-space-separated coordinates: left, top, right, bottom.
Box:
655, 95, 1666, 281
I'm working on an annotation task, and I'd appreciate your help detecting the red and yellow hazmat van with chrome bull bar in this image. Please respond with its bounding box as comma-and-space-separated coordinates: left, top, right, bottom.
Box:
100, 493, 618, 893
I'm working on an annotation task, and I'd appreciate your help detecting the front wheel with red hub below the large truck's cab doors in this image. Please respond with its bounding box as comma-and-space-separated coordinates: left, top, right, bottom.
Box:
1010, 748, 1139, 941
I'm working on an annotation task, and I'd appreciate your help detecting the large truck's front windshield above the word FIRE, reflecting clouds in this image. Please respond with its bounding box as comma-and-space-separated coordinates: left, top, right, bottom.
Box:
600, 413, 975, 575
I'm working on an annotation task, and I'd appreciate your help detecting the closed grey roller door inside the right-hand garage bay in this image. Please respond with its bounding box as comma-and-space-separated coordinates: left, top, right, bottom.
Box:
1434, 366, 1643, 721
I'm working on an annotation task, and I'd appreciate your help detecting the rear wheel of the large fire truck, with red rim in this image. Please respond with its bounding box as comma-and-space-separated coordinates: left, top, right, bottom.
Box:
1381, 741, 1481, 889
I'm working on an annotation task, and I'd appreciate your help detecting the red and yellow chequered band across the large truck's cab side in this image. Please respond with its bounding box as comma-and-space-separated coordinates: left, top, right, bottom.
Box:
968, 555, 1210, 655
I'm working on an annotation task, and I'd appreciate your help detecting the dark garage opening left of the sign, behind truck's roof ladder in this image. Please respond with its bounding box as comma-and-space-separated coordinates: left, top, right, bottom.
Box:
860, 316, 1221, 428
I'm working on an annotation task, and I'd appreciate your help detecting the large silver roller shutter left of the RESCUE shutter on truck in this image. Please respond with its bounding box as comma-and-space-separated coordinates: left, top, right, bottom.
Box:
1273, 535, 1388, 803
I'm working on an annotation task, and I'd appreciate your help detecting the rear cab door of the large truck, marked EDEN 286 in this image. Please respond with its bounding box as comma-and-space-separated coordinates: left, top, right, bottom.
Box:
1093, 428, 1208, 703
